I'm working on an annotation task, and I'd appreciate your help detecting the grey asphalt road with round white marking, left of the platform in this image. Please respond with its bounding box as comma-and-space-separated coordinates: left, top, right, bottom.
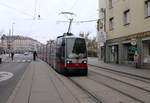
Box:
0, 54, 32, 103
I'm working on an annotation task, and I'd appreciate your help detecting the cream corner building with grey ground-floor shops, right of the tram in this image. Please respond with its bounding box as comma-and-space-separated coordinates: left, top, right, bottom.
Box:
100, 0, 150, 67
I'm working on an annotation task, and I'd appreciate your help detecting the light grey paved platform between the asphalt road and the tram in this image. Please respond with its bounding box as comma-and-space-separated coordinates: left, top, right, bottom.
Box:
6, 60, 82, 103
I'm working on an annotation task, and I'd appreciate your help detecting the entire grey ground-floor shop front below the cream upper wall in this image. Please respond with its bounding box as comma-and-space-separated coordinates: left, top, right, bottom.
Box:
106, 31, 150, 68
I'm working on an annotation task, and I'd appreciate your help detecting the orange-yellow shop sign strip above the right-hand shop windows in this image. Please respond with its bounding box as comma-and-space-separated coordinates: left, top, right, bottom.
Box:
126, 32, 150, 39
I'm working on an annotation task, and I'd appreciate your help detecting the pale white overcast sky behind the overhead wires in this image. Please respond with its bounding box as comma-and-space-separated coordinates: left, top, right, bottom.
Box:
0, 0, 98, 43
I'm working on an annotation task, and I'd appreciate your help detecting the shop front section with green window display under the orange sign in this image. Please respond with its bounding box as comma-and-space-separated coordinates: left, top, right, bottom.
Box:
123, 32, 150, 68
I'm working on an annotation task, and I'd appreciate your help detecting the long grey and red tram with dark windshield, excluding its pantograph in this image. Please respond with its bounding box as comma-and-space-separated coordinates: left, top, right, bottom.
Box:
39, 35, 88, 75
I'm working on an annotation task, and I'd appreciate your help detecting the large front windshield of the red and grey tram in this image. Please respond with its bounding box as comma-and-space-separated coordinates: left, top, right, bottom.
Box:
67, 38, 87, 59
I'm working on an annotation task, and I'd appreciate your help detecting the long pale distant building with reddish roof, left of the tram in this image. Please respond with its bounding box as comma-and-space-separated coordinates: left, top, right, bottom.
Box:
1, 35, 41, 53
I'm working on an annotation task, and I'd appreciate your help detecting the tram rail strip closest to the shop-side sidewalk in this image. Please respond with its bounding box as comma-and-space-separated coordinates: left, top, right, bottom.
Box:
88, 64, 150, 83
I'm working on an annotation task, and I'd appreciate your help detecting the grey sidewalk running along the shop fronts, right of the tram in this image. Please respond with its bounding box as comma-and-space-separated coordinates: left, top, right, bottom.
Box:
88, 58, 150, 79
